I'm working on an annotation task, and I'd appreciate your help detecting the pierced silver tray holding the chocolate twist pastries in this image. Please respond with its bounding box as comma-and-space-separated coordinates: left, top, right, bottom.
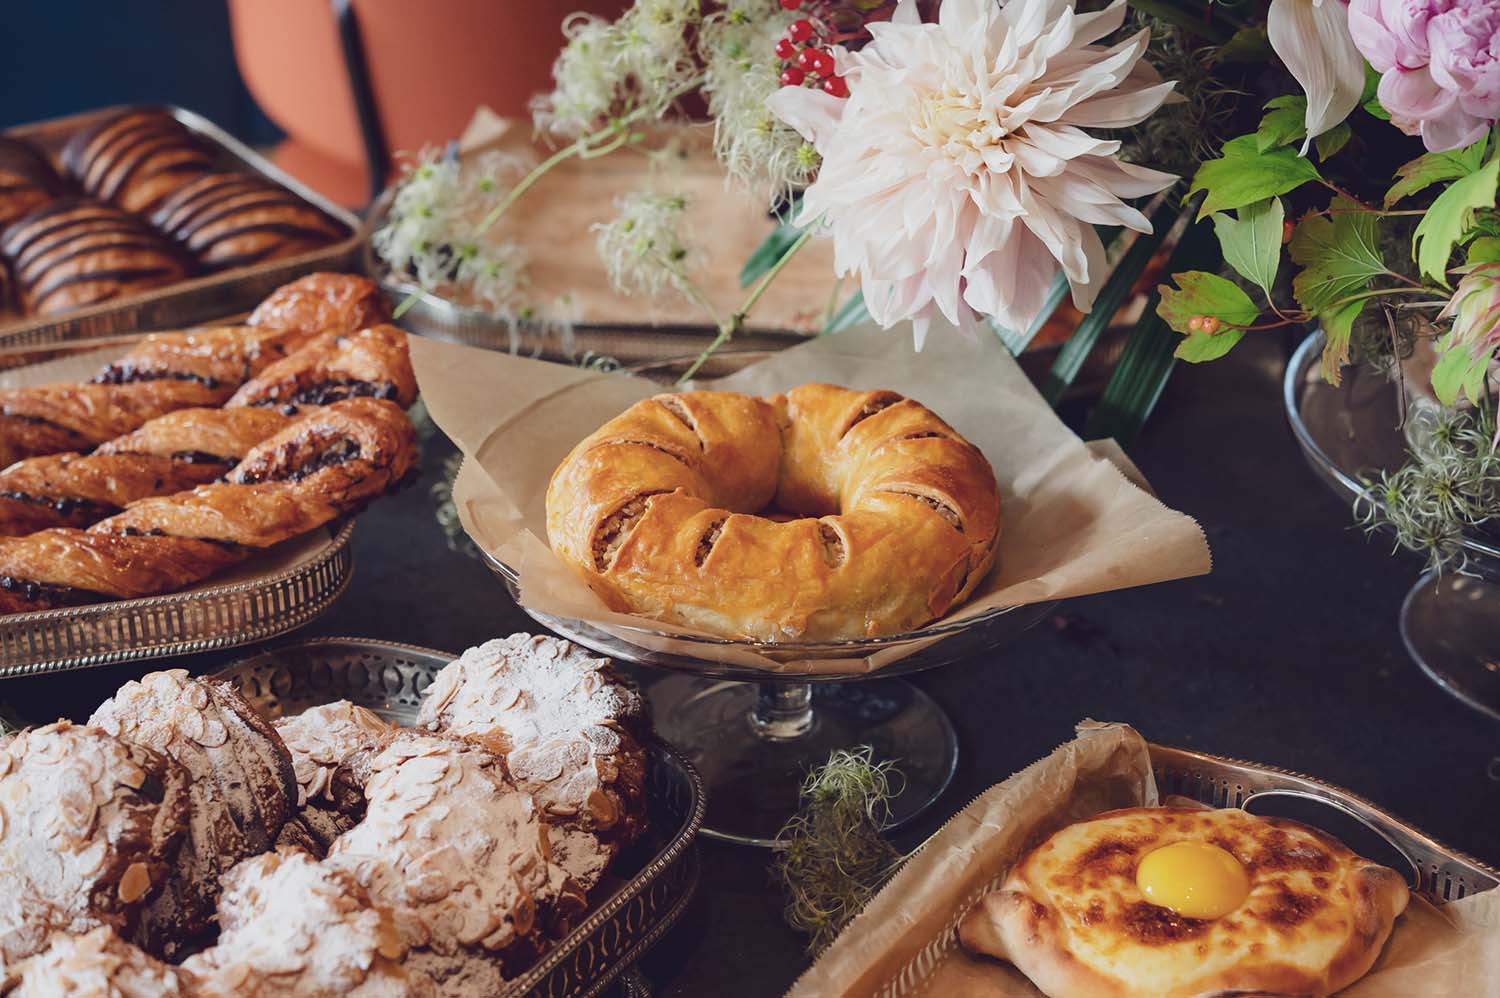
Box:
0, 521, 354, 680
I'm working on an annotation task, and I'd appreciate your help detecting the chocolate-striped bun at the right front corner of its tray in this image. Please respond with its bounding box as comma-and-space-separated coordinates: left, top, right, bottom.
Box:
152, 173, 345, 270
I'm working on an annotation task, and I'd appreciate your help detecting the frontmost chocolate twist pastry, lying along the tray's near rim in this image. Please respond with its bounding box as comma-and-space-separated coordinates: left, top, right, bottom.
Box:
0, 398, 417, 614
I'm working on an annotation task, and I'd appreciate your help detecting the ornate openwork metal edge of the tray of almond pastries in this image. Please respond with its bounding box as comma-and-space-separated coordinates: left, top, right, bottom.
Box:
216, 638, 705, 998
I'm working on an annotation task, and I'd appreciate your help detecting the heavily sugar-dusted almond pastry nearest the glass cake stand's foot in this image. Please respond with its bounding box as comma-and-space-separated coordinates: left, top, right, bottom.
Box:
417, 633, 645, 837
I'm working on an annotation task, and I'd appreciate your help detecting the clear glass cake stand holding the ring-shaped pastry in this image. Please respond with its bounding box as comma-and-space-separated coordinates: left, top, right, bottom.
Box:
485, 351, 1053, 846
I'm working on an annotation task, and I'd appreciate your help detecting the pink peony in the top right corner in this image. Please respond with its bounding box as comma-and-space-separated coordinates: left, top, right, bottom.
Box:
1349, 0, 1500, 152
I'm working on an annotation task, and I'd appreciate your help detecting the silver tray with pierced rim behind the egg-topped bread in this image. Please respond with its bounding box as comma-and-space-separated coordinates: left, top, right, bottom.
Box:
1151, 744, 1500, 905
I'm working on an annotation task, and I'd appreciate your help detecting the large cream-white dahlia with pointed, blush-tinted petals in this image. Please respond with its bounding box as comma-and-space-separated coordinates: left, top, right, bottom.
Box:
770, 0, 1175, 347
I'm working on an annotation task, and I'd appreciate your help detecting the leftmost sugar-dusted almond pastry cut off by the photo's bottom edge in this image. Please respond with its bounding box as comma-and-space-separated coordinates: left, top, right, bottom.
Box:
9, 927, 188, 998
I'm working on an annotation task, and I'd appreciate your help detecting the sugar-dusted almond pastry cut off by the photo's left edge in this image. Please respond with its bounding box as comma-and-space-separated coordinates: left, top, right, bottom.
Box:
0, 720, 189, 980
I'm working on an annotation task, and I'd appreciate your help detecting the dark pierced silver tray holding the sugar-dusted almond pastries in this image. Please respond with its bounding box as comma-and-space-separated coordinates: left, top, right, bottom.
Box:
218, 638, 704, 998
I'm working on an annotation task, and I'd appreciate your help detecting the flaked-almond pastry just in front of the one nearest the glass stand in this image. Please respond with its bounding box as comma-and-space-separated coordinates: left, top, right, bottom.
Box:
327, 731, 581, 954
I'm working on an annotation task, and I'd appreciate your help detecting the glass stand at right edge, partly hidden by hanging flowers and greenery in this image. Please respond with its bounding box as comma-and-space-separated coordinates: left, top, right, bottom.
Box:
1283, 332, 1500, 719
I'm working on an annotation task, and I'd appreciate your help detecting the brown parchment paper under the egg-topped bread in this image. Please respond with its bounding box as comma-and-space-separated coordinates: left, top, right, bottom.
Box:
788, 720, 1500, 998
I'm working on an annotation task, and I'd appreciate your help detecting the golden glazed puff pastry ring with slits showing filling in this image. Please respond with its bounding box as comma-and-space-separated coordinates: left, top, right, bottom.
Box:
548, 384, 1001, 641
